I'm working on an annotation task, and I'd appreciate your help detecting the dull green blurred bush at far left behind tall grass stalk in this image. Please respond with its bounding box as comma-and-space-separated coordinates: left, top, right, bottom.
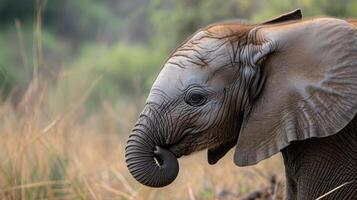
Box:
0, 23, 69, 99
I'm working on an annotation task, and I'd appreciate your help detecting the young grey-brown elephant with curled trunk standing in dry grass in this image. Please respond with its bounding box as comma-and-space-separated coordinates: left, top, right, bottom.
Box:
125, 9, 357, 200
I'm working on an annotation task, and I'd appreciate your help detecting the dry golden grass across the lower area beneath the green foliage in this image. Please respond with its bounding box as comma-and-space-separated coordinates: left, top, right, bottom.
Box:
0, 81, 283, 200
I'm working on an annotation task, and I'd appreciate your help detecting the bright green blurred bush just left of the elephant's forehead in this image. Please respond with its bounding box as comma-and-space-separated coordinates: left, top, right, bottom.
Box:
68, 42, 164, 99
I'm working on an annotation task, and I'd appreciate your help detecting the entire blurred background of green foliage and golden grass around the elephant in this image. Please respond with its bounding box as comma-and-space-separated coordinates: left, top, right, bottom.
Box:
0, 0, 357, 200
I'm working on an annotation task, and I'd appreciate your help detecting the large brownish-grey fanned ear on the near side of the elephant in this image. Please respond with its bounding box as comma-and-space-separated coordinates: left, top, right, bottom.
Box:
234, 18, 357, 166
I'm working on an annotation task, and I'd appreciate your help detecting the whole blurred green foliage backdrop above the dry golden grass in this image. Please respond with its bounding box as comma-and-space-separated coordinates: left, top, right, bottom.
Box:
0, 0, 357, 109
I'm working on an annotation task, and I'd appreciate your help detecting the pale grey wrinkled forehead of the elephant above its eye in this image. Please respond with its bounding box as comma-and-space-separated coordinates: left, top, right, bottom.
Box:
147, 31, 234, 103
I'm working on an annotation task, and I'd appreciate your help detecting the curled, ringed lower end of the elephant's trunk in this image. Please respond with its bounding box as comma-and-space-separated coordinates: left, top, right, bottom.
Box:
125, 111, 179, 187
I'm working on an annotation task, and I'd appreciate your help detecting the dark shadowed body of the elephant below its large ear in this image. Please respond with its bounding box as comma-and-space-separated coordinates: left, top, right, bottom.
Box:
282, 116, 357, 199
